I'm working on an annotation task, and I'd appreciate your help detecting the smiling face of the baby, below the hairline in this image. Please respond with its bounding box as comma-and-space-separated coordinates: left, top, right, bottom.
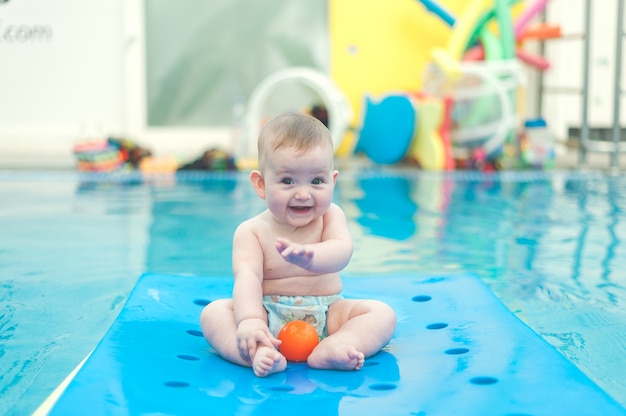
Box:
264, 147, 337, 227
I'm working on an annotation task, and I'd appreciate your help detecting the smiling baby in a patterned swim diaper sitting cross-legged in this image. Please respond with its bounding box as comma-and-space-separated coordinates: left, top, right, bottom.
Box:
200, 114, 396, 377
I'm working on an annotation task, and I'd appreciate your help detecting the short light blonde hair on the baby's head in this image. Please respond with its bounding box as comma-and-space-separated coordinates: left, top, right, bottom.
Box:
257, 113, 333, 169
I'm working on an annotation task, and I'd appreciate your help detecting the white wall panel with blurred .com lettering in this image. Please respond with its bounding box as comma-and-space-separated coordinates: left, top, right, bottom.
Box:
0, 0, 125, 167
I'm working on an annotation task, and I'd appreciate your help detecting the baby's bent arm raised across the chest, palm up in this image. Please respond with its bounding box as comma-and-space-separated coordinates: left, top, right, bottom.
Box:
276, 204, 352, 273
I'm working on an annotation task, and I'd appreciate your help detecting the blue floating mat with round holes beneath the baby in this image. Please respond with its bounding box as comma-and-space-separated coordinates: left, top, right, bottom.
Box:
50, 274, 626, 416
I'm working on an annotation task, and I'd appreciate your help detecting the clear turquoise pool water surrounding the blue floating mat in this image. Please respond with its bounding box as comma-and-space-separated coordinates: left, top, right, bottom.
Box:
0, 169, 626, 415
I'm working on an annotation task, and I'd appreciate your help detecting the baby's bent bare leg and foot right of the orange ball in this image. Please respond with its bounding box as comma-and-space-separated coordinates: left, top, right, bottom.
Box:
307, 299, 396, 370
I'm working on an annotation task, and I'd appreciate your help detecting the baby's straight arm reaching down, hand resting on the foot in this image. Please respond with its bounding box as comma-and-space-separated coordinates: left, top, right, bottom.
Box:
233, 223, 280, 362
